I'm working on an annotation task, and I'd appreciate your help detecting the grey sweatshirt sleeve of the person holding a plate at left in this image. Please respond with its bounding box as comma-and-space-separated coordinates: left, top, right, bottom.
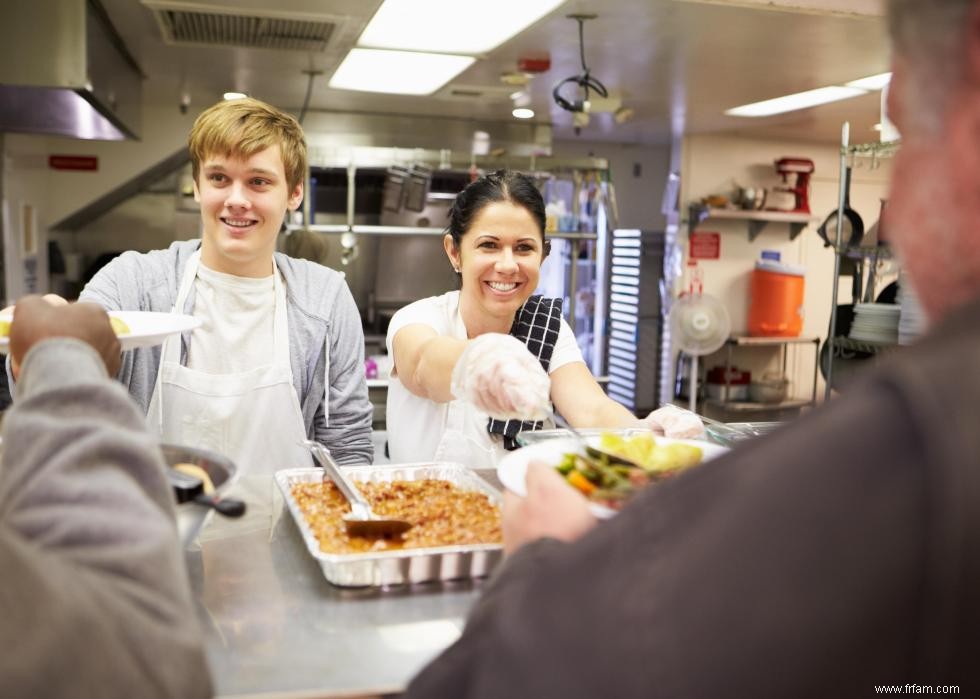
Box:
0, 339, 211, 698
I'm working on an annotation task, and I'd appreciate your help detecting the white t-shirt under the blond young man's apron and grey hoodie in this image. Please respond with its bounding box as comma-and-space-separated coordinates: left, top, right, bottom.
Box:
187, 264, 276, 374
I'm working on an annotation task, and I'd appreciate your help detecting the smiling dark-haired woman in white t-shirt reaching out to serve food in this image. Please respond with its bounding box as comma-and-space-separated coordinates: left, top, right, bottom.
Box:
387, 171, 688, 468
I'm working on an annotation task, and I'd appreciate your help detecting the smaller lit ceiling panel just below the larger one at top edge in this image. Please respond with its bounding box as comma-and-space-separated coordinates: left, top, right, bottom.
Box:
330, 49, 476, 95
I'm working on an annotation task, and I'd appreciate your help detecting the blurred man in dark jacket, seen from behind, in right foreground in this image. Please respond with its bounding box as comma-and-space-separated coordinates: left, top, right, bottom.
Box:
409, 0, 980, 699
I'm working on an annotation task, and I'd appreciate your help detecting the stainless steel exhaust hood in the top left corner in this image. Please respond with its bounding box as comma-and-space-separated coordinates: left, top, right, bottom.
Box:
0, 0, 143, 141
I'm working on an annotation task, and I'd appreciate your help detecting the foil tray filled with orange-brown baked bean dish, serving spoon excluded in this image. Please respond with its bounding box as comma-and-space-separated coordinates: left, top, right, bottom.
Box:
275, 462, 503, 587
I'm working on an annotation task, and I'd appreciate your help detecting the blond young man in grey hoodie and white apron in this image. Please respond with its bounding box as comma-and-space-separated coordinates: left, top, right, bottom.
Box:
80, 98, 373, 475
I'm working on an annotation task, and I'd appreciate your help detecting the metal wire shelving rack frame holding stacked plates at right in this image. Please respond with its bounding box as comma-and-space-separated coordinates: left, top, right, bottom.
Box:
824, 122, 900, 399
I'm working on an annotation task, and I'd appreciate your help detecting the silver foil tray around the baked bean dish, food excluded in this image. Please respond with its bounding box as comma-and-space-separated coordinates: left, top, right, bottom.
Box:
275, 462, 503, 587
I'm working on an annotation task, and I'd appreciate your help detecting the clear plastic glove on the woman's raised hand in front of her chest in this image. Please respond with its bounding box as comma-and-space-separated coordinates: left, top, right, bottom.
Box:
450, 333, 551, 420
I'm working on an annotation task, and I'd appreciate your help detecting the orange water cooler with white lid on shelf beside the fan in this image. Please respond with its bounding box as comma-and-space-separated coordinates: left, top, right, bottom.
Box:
749, 259, 804, 337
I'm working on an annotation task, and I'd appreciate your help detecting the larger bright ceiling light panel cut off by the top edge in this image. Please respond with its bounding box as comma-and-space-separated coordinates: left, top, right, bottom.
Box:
357, 0, 565, 54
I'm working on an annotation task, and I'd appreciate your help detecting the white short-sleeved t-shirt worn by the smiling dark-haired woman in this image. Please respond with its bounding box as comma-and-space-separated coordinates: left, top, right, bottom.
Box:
386, 291, 584, 463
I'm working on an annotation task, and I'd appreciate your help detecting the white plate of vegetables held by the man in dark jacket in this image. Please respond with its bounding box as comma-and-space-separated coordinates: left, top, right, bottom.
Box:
497, 432, 728, 517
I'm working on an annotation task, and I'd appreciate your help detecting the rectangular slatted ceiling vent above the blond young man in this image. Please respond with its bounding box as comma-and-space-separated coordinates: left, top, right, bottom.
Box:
144, 2, 337, 51
